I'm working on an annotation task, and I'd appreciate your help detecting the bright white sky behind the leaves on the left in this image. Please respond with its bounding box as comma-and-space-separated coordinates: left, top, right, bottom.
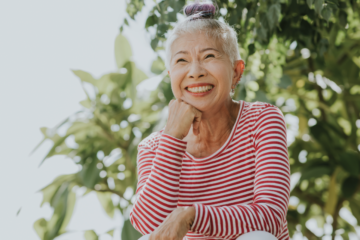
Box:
0, 0, 156, 240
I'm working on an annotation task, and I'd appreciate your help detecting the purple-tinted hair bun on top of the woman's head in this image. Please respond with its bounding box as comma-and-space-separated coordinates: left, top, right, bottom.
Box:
184, 1, 216, 20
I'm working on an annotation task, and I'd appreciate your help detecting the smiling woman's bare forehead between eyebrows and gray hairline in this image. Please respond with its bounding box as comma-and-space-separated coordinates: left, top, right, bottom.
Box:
171, 33, 222, 56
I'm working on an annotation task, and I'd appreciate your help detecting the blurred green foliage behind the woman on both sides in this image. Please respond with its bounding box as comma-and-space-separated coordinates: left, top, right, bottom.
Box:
34, 0, 360, 240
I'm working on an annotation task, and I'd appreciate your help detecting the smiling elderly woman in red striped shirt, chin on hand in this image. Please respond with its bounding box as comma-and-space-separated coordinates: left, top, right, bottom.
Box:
130, 0, 290, 240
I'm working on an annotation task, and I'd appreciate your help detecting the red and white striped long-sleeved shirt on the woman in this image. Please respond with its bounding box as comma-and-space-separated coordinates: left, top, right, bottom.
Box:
130, 101, 290, 240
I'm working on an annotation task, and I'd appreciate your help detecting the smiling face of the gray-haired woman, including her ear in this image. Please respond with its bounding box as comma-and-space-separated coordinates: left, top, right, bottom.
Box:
168, 31, 243, 111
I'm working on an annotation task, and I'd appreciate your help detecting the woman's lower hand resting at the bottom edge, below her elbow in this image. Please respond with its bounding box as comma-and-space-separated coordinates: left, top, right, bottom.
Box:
149, 207, 195, 240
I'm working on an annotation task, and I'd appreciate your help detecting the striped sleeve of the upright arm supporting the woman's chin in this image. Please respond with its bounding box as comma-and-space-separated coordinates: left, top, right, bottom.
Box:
130, 134, 187, 234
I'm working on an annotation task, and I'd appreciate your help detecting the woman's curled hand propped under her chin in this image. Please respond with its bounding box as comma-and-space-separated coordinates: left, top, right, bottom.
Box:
164, 99, 201, 139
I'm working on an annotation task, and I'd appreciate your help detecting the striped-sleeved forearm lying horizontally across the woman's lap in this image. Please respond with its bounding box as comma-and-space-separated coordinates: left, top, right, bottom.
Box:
190, 201, 285, 239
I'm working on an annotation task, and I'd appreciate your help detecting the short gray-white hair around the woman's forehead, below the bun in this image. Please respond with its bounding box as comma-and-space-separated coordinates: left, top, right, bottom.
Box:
165, 16, 241, 70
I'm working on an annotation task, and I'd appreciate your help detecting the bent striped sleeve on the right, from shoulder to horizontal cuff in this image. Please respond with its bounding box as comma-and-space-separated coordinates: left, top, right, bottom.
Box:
191, 105, 290, 239
